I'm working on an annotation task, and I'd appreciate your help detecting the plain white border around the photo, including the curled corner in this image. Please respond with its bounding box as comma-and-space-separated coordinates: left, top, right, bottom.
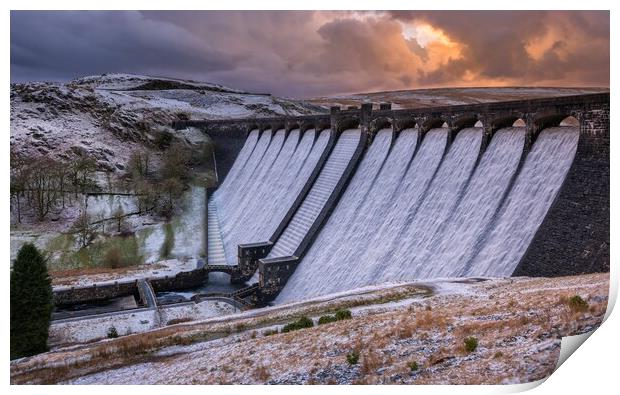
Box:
0, 0, 620, 395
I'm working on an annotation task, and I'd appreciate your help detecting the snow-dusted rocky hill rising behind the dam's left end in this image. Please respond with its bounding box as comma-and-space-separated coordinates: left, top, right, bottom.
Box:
11, 74, 324, 171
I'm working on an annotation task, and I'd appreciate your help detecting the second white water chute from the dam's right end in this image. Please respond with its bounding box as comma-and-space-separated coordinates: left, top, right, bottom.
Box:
415, 127, 526, 278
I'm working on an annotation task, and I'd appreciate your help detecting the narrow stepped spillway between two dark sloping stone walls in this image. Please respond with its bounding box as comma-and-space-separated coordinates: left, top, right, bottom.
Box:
267, 129, 361, 258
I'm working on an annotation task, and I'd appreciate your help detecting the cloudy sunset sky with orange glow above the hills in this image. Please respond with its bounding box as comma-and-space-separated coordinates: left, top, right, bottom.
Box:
10, 11, 610, 97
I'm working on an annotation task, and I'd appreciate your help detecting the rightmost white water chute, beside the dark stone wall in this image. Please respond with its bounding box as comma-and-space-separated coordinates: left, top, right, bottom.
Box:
465, 126, 579, 277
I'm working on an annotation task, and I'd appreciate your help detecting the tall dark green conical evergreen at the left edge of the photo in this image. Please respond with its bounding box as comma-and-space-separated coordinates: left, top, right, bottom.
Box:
10, 243, 54, 359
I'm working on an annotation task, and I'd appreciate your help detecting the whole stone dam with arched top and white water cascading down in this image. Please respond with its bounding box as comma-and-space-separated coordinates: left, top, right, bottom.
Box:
177, 94, 609, 303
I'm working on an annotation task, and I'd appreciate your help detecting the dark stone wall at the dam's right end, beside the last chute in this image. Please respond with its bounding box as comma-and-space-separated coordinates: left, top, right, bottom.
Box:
514, 102, 610, 276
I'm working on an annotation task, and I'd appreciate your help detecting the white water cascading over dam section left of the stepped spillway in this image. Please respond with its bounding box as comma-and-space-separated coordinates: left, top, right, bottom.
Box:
208, 129, 329, 265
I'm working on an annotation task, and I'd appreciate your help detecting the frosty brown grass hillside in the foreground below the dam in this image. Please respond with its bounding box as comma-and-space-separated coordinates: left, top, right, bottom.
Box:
11, 273, 609, 384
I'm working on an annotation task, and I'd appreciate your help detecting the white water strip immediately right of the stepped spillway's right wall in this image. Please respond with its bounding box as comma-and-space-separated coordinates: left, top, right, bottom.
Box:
276, 129, 392, 300
